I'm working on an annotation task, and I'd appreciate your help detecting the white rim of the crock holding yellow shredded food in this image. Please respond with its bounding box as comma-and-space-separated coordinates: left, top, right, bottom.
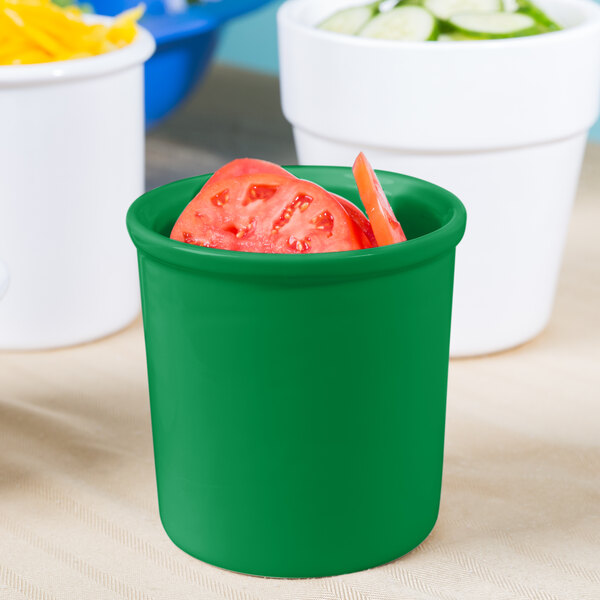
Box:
0, 15, 156, 87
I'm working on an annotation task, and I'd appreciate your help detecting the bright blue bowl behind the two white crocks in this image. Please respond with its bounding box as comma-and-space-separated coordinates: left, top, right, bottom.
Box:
92, 0, 270, 127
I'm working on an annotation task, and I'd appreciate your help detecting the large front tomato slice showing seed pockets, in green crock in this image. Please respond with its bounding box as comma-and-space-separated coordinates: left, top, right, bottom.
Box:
171, 173, 363, 254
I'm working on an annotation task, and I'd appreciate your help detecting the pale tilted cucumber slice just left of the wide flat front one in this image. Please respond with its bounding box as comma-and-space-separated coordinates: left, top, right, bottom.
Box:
358, 6, 438, 42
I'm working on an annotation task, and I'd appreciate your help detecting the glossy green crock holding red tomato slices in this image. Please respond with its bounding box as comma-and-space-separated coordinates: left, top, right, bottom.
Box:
127, 167, 466, 577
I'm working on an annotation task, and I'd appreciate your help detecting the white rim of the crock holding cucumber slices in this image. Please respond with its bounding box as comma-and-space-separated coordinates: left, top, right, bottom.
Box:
277, 0, 600, 52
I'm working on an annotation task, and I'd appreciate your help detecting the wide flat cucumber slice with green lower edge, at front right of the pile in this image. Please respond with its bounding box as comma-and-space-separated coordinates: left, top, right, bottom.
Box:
449, 12, 541, 40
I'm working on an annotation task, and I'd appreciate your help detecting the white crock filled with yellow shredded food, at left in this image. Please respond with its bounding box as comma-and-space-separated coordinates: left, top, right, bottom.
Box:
0, 24, 154, 349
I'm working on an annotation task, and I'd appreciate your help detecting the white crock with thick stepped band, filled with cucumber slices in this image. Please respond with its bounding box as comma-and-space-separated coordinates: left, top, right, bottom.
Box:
278, 0, 600, 356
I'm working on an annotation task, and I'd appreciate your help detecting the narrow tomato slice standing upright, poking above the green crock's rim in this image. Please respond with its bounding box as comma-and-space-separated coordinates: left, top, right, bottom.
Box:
352, 152, 406, 246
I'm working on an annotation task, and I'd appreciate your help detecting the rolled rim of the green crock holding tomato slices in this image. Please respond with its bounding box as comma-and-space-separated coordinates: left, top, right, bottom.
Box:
127, 166, 467, 278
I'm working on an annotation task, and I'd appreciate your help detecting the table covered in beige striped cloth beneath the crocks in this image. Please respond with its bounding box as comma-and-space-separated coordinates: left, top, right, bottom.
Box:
0, 67, 600, 600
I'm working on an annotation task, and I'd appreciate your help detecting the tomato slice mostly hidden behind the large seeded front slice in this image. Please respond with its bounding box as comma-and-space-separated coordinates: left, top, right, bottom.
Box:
207, 158, 377, 248
